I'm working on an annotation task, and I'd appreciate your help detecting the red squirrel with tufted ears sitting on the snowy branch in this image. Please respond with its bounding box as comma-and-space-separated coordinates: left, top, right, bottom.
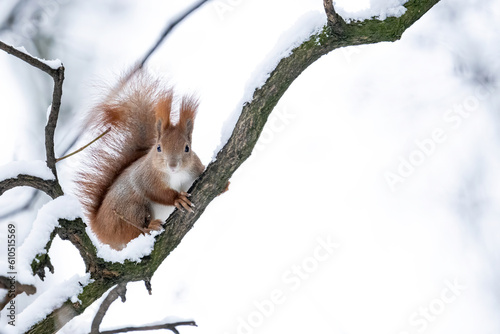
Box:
76, 73, 205, 250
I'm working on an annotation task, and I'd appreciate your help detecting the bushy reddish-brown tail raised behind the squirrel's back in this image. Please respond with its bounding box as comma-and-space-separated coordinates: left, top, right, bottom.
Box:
76, 72, 172, 221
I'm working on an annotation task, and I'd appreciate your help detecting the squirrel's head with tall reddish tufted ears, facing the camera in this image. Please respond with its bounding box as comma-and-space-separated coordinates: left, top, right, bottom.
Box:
153, 92, 198, 174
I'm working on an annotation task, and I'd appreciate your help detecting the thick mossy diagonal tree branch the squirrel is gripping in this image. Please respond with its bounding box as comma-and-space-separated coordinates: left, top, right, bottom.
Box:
25, 0, 439, 334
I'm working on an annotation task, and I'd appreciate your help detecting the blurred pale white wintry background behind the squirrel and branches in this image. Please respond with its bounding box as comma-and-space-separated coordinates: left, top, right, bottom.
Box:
0, 0, 500, 334
